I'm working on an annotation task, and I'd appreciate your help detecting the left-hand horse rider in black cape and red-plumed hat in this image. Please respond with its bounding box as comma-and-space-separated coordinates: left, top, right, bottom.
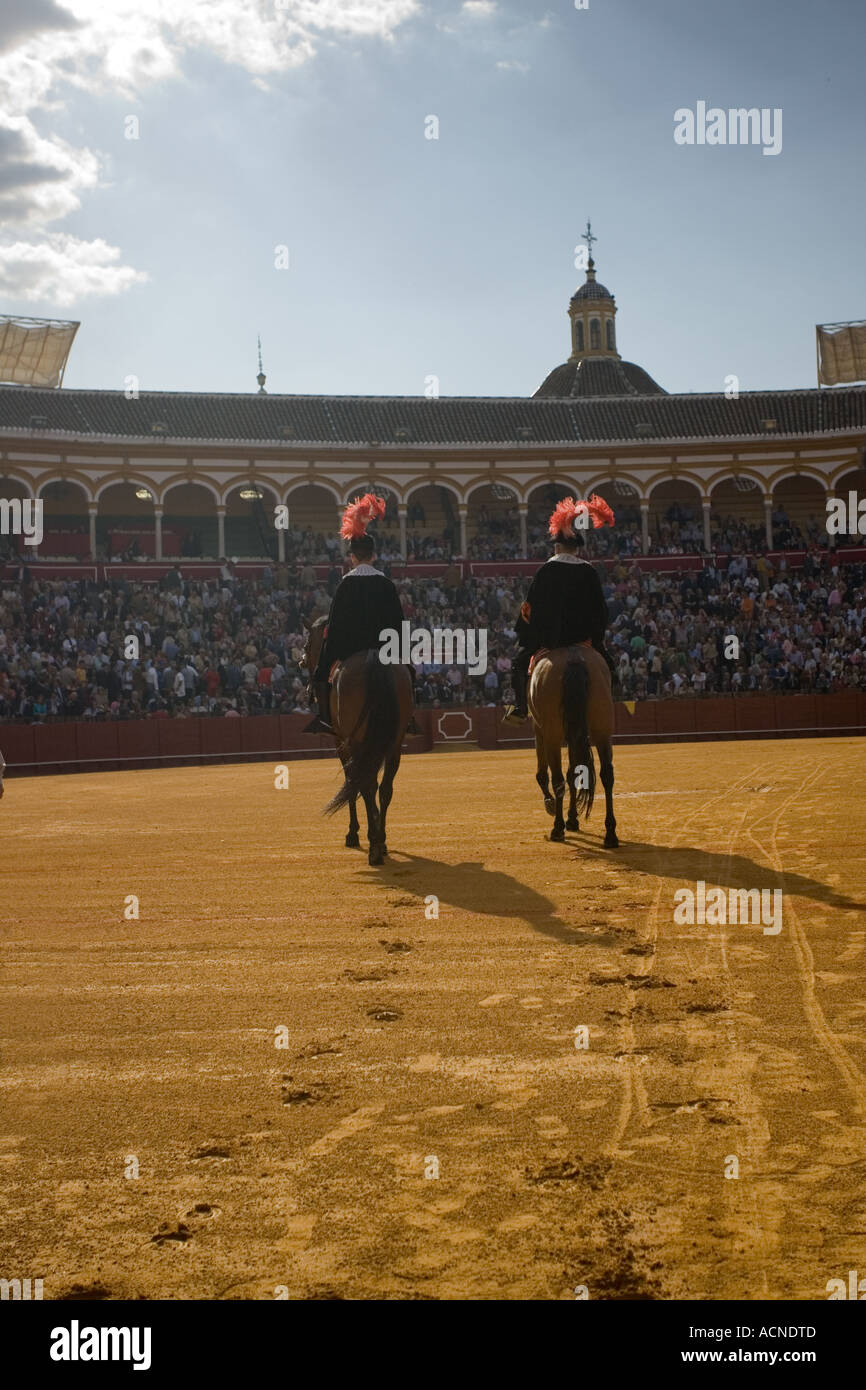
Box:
304, 492, 403, 734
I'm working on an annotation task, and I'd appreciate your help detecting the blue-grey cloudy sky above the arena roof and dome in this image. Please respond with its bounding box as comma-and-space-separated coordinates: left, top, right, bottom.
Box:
0, 0, 866, 396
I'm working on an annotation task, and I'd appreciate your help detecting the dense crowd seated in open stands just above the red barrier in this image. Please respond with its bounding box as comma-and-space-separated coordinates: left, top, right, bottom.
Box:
0, 550, 866, 723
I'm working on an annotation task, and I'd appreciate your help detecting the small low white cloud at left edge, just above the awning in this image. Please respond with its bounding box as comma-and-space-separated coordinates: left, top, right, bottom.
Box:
0, 232, 147, 309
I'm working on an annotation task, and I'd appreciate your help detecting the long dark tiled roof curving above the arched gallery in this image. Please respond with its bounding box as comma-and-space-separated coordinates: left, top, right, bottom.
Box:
0, 380, 866, 444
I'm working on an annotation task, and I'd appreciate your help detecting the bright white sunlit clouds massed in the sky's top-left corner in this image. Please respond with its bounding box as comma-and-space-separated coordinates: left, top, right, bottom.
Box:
0, 0, 419, 304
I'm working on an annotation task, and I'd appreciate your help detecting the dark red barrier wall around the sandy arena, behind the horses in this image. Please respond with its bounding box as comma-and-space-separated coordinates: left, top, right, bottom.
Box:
0, 691, 866, 776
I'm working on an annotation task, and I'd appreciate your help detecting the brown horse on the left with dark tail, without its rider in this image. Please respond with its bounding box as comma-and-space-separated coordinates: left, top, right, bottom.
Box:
304, 617, 413, 865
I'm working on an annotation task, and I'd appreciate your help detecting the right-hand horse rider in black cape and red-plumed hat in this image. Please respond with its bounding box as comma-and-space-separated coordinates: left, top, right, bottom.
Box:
505, 493, 617, 724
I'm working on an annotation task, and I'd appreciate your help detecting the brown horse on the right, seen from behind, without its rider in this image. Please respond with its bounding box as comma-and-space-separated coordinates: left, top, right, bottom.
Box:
530, 644, 619, 849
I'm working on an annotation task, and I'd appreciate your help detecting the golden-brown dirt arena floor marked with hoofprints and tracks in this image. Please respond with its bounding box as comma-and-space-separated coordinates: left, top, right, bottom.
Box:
0, 738, 866, 1300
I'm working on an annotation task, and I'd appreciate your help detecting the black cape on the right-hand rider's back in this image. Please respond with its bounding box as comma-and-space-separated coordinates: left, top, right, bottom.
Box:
517, 560, 607, 652
